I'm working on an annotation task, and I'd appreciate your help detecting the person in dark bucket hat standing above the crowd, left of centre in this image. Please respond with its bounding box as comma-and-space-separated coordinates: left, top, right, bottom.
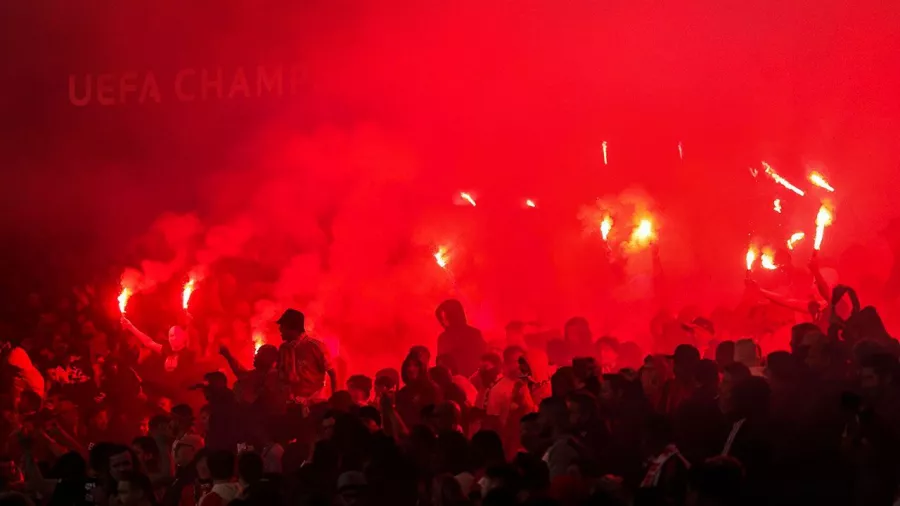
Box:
276, 309, 337, 402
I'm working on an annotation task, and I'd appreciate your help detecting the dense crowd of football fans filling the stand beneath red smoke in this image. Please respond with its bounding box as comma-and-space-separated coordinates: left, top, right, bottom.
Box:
0, 270, 900, 506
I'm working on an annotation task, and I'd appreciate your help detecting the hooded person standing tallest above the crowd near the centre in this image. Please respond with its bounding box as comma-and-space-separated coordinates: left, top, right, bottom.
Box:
435, 299, 487, 376
